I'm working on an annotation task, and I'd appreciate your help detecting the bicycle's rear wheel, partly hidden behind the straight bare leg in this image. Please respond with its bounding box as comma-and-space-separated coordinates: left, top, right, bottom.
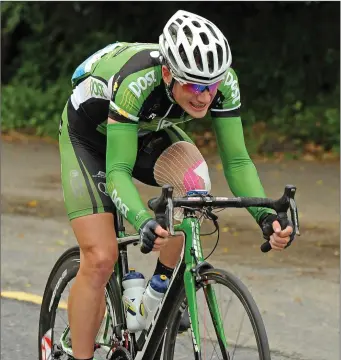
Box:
38, 246, 123, 360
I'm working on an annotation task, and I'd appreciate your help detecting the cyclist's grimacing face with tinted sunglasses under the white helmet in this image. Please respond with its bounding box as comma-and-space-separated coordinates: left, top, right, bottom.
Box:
163, 67, 220, 118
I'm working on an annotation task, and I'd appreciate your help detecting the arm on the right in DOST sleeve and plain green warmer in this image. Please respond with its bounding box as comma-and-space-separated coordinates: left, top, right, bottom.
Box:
211, 69, 272, 222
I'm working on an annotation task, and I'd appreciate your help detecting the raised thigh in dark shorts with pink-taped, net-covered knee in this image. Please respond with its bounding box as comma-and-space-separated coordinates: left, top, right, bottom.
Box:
133, 126, 211, 196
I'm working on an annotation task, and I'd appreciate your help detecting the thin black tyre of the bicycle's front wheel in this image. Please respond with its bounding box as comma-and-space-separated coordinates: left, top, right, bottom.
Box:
163, 269, 271, 360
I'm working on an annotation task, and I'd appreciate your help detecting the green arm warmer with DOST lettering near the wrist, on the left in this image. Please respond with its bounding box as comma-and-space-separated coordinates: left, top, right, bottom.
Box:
106, 123, 152, 231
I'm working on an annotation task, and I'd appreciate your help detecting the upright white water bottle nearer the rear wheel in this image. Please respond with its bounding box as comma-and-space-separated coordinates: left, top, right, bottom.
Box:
122, 269, 146, 332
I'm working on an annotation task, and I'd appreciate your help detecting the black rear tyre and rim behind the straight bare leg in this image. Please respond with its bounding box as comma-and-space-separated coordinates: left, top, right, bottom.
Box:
38, 246, 123, 360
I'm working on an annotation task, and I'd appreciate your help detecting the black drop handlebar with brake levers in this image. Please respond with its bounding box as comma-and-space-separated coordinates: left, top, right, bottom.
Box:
145, 185, 300, 252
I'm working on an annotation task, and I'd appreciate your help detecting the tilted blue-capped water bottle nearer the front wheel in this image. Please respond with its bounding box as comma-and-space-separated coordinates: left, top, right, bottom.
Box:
142, 275, 169, 324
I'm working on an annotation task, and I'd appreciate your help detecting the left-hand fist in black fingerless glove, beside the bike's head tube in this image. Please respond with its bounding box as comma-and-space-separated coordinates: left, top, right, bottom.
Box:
140, 219, 169, 253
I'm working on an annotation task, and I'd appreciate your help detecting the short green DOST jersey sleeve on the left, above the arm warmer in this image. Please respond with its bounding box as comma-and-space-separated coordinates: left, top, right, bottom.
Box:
109, 67, 160, 123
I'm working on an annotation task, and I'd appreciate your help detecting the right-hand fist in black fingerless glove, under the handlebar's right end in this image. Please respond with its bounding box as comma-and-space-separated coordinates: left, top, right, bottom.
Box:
261, 214, 293, 251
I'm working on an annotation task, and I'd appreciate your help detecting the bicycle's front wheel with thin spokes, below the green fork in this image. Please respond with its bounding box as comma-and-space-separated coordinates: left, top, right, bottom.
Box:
163, 269, 271, 360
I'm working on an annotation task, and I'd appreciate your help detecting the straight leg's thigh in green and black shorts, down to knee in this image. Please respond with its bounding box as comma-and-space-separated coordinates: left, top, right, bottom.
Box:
59, 101, 115, 251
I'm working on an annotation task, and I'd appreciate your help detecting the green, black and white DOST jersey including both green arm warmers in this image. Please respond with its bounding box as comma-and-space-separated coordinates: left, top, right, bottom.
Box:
61, 42, 271, 230
